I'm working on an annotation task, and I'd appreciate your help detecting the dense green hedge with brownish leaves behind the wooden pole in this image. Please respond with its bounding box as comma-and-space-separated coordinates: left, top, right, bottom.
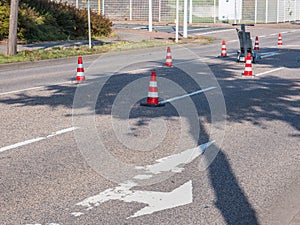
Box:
0, 0, 112, 42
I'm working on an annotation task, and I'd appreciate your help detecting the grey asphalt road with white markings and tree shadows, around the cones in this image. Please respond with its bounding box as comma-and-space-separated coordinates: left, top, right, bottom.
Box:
0, 28, 300, 225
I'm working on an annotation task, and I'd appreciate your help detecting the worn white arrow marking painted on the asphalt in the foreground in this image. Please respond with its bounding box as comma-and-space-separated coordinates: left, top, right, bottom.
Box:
71, 141, 214, 218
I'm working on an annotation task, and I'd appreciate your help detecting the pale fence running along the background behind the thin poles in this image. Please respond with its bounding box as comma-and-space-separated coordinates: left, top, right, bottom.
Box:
63, 0, 300, 23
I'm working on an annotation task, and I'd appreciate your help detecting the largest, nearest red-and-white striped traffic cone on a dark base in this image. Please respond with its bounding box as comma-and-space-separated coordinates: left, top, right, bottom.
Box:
140, 70, 165, 107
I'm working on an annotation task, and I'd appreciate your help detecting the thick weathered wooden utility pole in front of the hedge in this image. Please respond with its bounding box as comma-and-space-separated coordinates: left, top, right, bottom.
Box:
7, 0, 19, 55
